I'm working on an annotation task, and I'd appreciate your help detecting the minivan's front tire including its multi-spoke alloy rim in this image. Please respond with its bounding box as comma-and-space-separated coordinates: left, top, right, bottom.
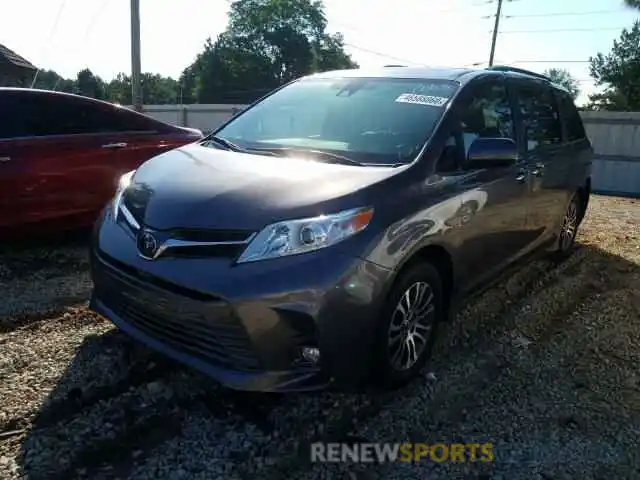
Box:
372, 262, 444, 389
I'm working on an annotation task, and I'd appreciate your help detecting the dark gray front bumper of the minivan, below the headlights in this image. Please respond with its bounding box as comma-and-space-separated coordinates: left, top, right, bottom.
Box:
90, 214, 391, 392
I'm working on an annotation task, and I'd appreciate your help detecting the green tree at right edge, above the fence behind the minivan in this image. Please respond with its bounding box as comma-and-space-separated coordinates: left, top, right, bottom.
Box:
589, 21, 640, 111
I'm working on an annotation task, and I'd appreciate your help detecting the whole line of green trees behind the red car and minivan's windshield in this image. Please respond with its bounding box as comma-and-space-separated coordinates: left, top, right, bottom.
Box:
1, 0, 357, 105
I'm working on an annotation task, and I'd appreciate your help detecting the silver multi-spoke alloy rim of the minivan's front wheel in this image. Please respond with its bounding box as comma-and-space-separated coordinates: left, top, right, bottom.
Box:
388, 281, 435, 371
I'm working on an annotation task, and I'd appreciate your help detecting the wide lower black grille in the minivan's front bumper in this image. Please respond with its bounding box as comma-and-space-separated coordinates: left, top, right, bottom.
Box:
95, 258, 259, 370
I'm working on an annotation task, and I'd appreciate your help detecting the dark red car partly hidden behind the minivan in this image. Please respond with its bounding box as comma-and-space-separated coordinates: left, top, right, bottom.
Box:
0, 88, 202, 241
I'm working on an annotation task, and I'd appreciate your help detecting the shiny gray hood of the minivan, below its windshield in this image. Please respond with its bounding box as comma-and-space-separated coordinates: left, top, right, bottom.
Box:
126, 144, 400, 230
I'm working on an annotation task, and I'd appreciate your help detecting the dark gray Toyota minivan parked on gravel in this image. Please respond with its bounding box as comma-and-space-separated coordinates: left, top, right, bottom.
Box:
91, 66, 592, 392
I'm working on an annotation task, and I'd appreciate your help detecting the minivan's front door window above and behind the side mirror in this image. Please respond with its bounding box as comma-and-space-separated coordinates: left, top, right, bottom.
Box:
437, 80, 515, 173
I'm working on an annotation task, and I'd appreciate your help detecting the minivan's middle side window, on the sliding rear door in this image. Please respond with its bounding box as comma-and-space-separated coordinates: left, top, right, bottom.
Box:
517, 83, 562, 151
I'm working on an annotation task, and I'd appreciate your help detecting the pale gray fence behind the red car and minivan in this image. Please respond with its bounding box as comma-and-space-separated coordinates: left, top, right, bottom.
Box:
138, 105, 640, 197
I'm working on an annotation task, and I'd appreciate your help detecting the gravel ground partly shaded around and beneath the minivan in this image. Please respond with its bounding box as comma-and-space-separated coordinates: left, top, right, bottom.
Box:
0, 196, 640, 480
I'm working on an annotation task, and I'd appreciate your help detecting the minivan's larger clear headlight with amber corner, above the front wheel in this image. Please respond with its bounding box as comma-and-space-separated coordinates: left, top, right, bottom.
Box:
238, 208, 373, 263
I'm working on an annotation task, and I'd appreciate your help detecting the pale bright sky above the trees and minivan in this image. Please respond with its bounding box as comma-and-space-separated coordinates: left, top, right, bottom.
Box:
0, 0, 640, 103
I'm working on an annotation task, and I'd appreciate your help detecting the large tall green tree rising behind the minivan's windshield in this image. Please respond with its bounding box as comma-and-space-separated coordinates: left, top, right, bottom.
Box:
179, 0, 357, 103
